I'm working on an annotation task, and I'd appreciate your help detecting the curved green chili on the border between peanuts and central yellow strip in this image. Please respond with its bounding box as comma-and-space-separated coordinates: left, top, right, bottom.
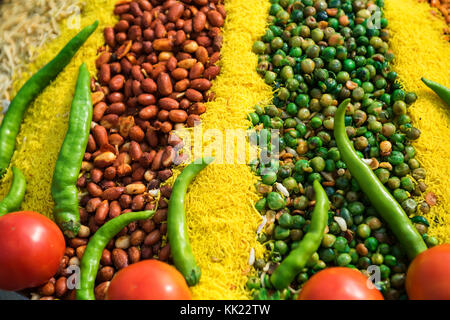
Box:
167, 157, 214, 286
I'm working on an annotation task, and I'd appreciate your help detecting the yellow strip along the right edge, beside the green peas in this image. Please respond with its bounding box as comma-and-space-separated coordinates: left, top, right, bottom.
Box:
385, 0, 450, 242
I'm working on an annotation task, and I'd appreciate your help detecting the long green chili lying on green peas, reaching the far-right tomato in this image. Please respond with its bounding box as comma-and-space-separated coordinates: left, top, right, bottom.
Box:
334, 99, 427, 259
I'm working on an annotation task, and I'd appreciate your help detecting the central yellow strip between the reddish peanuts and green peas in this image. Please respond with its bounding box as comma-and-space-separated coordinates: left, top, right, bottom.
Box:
181, 0, 272, 299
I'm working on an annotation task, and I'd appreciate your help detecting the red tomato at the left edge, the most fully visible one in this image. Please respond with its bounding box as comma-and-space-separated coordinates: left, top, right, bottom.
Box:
0, 211, 65, 291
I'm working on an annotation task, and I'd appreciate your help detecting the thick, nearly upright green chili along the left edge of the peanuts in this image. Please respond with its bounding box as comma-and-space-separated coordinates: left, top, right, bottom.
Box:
52, 63, 92, 237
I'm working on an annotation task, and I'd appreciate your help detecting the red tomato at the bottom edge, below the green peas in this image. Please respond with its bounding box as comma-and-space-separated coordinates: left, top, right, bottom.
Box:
298, 267, 384, 300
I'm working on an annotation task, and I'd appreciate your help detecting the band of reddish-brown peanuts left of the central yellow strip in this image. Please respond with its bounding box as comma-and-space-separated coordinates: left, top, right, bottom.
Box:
28, 0, 225, 300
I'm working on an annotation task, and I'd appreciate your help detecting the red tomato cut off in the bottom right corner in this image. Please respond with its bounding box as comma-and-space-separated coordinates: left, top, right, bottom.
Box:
406, 244, 450, 300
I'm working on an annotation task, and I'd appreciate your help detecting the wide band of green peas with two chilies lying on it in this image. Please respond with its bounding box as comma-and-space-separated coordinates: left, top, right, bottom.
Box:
247, 0, 437, 299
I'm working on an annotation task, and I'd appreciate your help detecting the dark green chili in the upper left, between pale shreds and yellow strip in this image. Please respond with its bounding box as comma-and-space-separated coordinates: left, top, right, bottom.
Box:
0, 21, 98, 177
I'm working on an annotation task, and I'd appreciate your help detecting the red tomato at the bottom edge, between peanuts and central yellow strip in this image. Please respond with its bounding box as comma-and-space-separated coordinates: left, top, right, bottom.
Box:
107, 260, 192, 300
